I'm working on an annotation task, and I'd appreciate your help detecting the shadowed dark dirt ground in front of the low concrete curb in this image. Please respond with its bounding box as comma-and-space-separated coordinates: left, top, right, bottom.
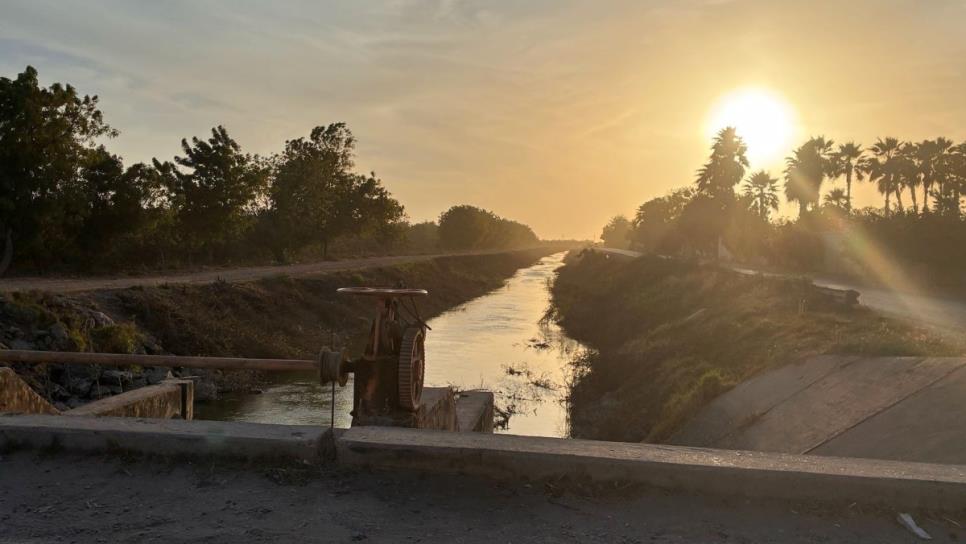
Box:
0, 451, 966, 544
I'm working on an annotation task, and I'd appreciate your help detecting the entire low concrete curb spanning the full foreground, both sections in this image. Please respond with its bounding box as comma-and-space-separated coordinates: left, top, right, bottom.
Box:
0, 415, 966, 509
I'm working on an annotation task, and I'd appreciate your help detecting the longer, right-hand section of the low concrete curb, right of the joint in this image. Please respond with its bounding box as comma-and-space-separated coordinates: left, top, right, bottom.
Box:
336, 427, 966, 509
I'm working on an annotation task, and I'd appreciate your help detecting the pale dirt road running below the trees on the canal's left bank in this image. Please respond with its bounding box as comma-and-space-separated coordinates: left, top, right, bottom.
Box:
0, 248, 563, 293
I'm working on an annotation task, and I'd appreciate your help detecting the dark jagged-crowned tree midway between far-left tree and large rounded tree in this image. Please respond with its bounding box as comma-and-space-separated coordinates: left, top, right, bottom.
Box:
154, 126, 268, 260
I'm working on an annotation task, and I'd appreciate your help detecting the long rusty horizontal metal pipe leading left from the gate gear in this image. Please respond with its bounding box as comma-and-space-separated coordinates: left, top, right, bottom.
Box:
0, 349, 319, 372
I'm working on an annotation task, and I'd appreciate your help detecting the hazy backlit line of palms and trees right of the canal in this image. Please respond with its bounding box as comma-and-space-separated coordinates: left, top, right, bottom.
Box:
601, 127, 966, 283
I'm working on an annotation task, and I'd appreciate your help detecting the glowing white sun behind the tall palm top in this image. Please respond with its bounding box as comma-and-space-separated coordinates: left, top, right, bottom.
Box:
705, 87, 797, 168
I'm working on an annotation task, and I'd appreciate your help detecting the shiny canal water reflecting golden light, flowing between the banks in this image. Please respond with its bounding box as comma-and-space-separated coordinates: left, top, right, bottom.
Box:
195, 253, 583, 437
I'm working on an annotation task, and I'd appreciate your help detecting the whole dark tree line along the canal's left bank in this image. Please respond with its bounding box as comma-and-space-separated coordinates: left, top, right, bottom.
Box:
0, 66, 536, 273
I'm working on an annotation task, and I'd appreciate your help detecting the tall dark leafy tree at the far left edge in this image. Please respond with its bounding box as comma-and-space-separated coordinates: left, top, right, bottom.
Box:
0, 66, 117, 273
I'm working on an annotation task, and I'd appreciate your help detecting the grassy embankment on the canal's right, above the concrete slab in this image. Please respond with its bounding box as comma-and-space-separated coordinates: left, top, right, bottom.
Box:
552, 252, 964, 442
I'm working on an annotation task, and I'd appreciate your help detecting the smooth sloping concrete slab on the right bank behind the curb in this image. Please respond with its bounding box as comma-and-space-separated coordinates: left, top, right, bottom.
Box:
671, 357, 966, 463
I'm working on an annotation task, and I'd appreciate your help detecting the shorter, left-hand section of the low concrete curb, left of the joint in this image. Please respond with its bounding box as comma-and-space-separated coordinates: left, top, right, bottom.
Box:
0, 415, 328, 462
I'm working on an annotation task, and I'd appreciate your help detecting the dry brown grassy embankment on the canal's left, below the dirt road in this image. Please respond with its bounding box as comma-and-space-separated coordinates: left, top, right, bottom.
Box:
0, 247, 559, 405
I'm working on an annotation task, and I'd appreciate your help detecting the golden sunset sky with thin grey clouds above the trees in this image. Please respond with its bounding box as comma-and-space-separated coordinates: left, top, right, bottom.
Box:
0, 0, 966, 238
